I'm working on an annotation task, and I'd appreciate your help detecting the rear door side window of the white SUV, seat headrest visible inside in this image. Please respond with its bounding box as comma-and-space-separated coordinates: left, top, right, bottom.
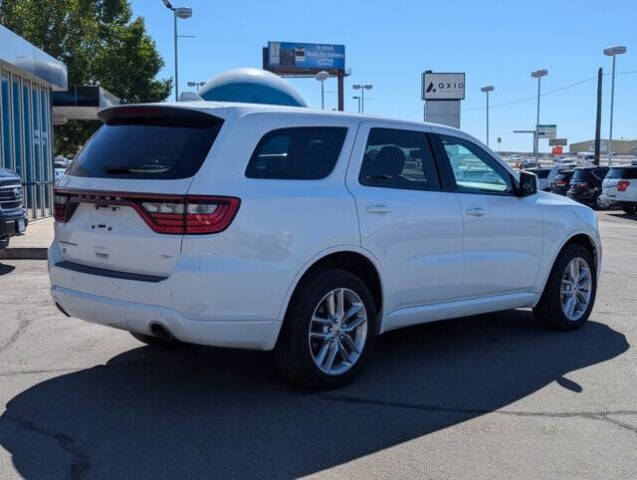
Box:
359, 128, 440, 190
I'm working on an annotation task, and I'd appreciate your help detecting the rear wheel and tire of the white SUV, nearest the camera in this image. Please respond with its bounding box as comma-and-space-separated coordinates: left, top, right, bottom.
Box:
274, 270, 378, 389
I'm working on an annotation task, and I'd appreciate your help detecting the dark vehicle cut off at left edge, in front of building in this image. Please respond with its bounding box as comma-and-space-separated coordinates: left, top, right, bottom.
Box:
0, 168, 27, 248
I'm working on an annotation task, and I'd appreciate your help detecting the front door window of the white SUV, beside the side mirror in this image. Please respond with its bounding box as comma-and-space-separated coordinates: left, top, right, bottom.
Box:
440, 135, 513, 194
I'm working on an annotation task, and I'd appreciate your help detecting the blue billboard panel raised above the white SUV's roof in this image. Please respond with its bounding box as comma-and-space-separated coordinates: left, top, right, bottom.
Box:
263, 42, 345, 73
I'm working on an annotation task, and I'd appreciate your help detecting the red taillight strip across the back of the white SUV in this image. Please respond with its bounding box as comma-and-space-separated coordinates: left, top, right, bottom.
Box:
55, 190, 241, 235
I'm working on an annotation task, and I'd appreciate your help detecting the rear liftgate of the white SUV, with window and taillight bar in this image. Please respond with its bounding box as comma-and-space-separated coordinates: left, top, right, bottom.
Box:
55, 106, 230, 276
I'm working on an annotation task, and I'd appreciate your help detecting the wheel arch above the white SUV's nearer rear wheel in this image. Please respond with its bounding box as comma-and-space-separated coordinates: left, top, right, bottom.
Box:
279, 246, 385, 332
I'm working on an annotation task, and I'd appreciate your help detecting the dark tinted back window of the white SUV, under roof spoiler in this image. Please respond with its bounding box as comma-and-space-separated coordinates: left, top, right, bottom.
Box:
67, 109, 223, 179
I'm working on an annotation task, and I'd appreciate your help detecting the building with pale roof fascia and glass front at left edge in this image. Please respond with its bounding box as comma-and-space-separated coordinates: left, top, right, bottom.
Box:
0, 25, 119, 219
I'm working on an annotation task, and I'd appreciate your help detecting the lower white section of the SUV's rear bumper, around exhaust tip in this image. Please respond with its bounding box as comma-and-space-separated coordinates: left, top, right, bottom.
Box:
51, 286, 279, 350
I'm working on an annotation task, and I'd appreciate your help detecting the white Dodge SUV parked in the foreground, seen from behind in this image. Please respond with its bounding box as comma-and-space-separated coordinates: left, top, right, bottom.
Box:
49, 102, 601, 388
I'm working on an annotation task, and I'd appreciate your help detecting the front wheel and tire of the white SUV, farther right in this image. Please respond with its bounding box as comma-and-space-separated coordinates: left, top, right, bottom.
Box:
533, 244, 597, 331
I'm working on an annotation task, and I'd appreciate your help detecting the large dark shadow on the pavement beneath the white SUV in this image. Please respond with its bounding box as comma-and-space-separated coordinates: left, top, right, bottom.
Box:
0, 310, 629, 479
